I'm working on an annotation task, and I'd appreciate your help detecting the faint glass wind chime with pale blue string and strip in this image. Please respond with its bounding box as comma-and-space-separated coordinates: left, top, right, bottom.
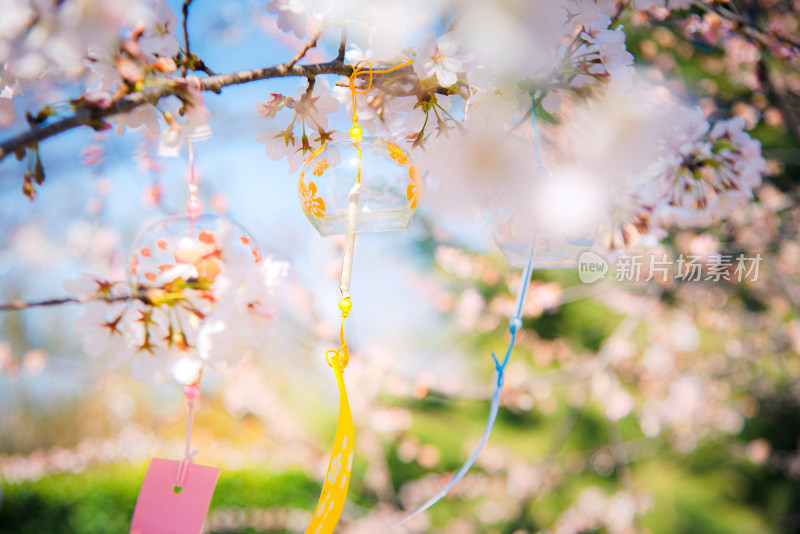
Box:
395, 95, 594, 526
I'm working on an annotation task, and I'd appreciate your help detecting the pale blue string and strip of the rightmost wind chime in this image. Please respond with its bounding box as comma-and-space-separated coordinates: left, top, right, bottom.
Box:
394, 102, 542, 527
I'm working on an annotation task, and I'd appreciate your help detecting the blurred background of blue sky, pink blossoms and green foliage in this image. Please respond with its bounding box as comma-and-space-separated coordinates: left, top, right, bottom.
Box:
0, 2, 800, 534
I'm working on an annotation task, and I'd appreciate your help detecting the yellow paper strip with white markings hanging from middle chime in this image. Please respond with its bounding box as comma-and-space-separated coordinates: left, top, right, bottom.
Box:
306, 356, 355, 534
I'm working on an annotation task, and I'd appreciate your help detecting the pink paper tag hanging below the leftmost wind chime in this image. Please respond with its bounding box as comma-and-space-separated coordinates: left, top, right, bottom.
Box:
131, 458, 219, 534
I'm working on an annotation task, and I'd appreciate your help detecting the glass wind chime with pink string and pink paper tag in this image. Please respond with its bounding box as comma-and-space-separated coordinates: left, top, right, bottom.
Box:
127, 144, 260, 534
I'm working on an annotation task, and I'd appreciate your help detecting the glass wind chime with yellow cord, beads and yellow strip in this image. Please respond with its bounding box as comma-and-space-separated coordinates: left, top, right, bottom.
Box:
298, 60, 420, 534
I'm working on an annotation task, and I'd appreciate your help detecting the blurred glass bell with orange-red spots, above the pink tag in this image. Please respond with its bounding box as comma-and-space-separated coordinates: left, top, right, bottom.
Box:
126, 214, 261, 287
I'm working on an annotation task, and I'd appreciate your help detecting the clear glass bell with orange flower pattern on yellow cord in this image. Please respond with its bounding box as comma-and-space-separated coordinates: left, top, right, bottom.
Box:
298, 137, 421, 236
